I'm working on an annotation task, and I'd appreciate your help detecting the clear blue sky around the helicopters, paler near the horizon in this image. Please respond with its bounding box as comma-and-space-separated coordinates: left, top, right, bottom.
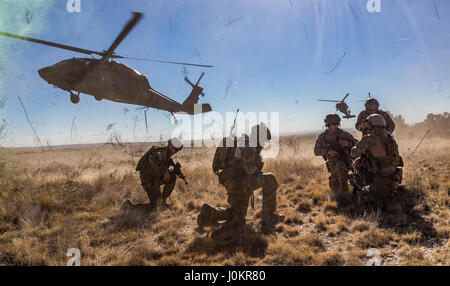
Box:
0, 0, 450, 146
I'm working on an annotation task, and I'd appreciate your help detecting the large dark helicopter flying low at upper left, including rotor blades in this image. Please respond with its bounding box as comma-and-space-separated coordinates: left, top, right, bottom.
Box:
0, 12, 212, 114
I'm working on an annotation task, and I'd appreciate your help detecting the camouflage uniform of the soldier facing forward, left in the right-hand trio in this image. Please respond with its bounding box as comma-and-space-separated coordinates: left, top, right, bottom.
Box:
314, 129, 358, 195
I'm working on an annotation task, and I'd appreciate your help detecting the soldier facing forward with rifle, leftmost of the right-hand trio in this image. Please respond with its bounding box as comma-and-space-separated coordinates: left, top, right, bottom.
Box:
314, 113, 358, 201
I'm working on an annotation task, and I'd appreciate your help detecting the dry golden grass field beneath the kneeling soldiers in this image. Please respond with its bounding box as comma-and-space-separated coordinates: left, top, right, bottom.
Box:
0, 136, 450, 265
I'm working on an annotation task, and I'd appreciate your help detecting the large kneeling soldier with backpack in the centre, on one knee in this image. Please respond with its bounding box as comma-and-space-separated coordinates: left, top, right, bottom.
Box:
197, 124, 284, 233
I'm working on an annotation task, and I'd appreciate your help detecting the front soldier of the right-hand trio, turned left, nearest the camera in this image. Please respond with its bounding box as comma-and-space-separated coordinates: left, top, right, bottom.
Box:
351, 114, 403, 203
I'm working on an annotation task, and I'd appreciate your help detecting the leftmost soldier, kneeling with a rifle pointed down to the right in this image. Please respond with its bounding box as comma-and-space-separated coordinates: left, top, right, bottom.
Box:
136, 138, 183, 210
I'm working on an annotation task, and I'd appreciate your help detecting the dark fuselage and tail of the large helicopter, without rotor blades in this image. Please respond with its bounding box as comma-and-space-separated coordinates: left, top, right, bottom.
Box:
38, 58, 211, 114
